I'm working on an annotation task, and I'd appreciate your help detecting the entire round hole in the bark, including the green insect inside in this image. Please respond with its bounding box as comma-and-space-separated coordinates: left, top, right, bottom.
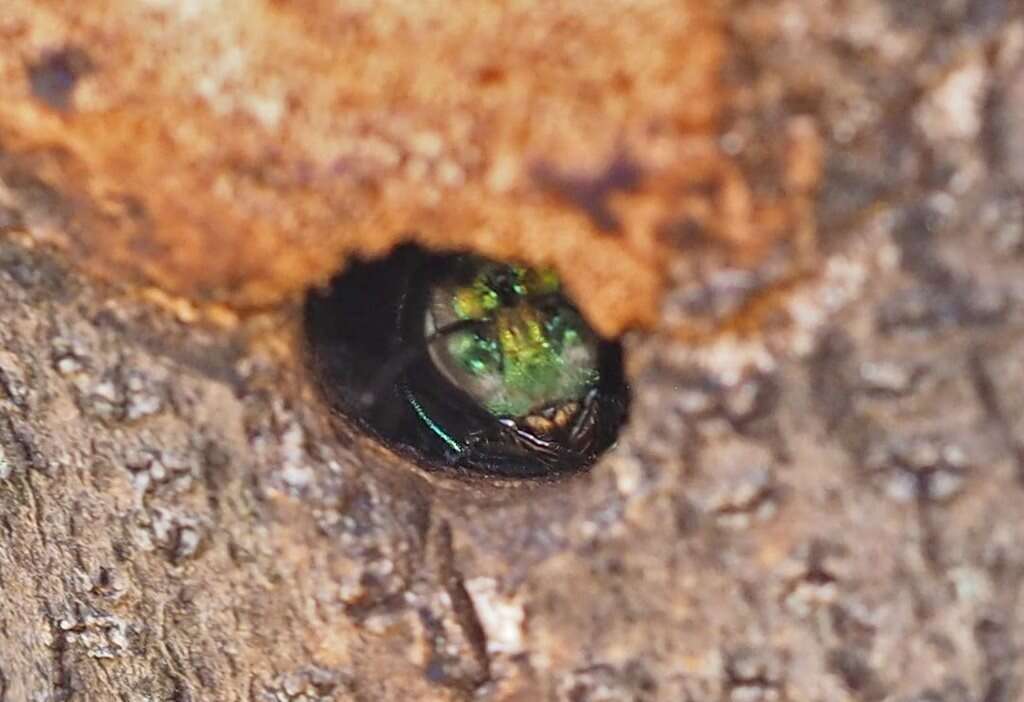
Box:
305, 247, 629, 478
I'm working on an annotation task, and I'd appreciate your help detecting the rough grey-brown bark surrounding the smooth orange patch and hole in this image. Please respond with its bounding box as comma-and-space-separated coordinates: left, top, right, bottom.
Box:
0, 0, 1024, 702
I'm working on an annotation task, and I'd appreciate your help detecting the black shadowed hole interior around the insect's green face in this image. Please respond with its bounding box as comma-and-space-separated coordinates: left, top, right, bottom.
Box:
304, 246, 629, 479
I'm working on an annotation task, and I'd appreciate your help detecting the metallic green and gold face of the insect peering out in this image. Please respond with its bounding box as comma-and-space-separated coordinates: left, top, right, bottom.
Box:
427, 257, 599, 418
